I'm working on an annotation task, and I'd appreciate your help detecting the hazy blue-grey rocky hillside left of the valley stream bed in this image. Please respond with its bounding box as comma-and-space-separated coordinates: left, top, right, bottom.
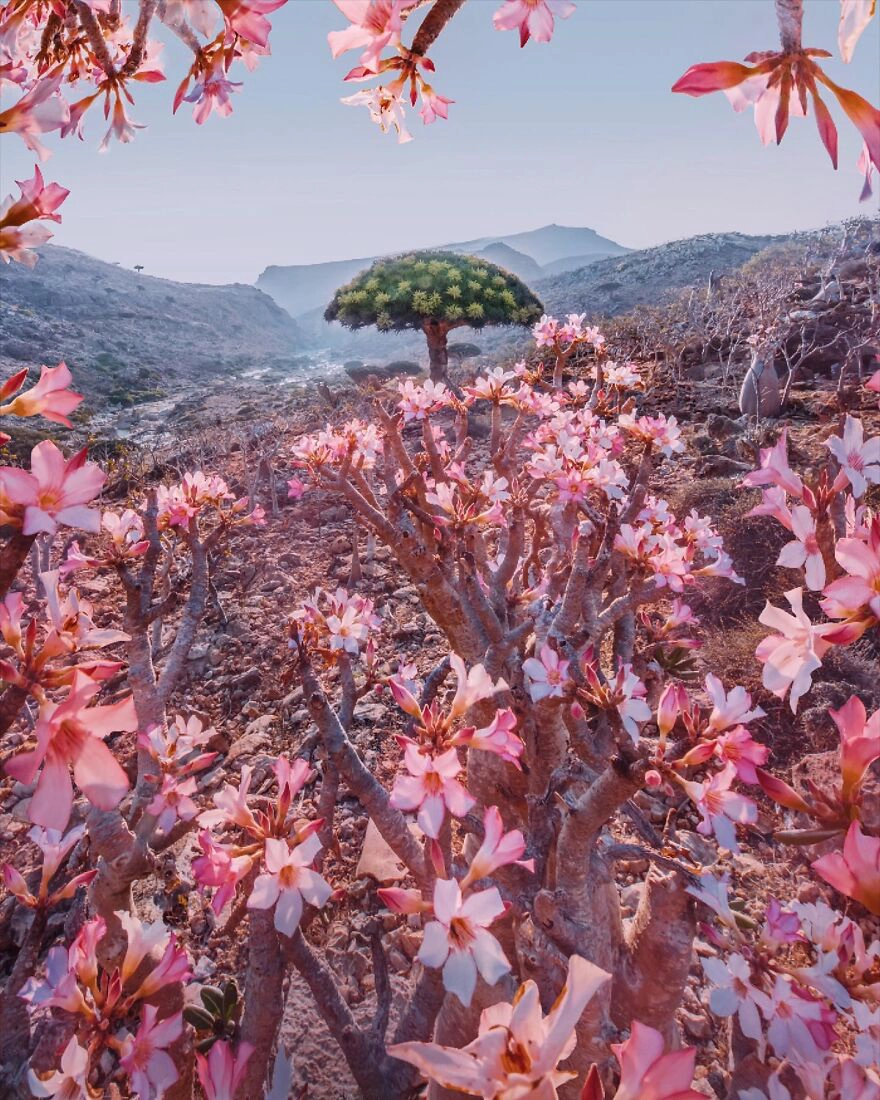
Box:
0, 245, 304, 410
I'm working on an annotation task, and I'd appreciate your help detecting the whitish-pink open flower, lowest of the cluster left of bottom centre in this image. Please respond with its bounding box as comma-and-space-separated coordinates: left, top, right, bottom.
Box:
248, 833, 332, 936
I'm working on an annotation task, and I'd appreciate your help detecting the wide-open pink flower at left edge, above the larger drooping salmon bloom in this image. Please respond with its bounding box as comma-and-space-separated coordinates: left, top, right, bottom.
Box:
0, 439, 106, 535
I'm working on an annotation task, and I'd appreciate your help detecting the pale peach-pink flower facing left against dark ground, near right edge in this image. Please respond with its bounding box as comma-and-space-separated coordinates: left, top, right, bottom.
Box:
755, 589, 835, 713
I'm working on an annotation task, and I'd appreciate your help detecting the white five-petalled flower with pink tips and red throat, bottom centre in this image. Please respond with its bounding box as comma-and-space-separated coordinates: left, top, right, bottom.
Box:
418, 879, 510, 1008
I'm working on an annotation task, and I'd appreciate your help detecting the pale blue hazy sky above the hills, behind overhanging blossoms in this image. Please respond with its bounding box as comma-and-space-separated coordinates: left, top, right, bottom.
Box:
0, 0, 880, 283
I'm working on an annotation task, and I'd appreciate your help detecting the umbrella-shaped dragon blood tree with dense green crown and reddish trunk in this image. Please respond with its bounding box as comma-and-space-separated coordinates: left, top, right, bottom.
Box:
323, 252, 543, 382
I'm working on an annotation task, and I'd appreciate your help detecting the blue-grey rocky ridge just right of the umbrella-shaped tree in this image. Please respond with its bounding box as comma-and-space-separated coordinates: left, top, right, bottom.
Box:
534, 233, 787, 317
